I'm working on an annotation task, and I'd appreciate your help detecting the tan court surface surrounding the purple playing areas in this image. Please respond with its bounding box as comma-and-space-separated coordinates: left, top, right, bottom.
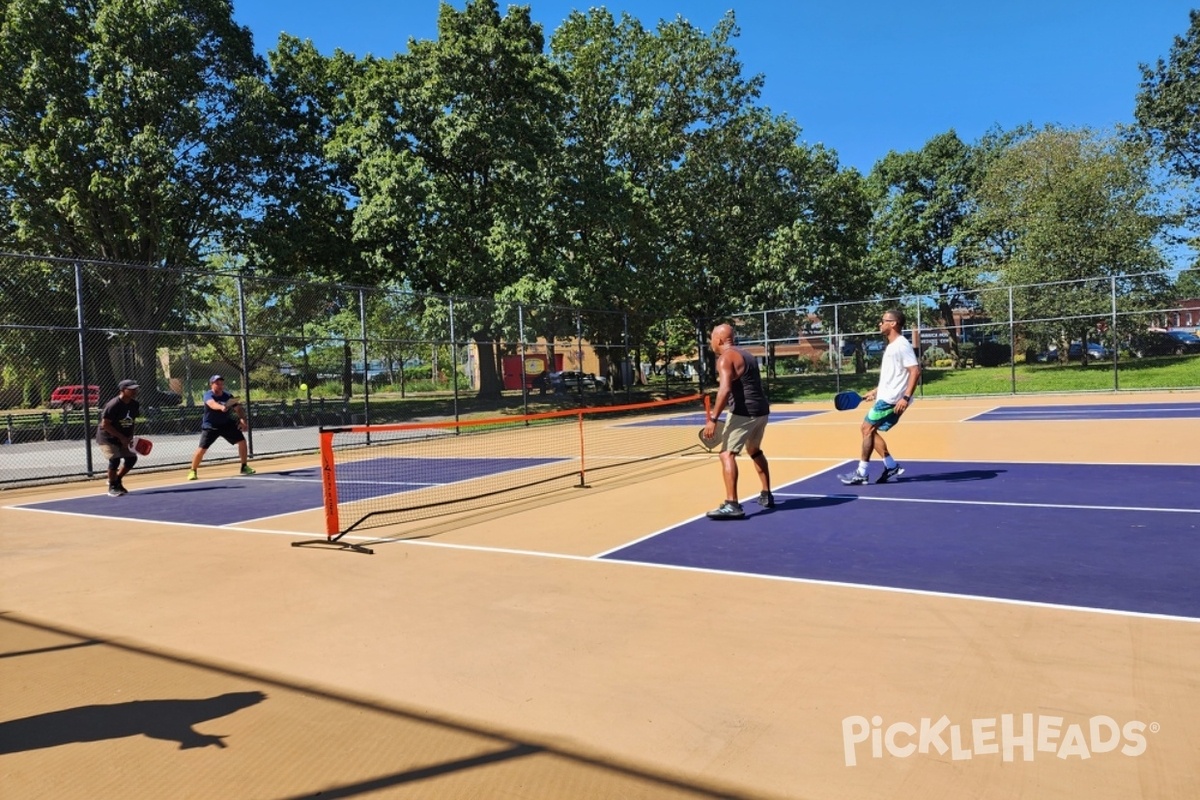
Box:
0, 392, 1200, 800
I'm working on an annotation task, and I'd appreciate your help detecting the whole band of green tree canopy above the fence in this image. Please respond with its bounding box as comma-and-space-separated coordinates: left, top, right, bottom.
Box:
0, 0, 1200, 395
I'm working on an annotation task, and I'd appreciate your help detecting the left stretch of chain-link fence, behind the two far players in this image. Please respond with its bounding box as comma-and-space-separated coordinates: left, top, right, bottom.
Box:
0, 254, 710, 486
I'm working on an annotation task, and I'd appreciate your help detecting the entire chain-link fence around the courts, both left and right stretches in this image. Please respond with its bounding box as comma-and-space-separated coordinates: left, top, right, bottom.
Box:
0, 254, 1200, 487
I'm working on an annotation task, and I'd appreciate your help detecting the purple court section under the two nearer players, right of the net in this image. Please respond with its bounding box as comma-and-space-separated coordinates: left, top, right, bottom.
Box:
604, 462, 1200, 619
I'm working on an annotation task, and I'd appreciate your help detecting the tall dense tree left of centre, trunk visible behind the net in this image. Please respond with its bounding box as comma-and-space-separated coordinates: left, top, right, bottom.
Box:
340, 0, 564, 397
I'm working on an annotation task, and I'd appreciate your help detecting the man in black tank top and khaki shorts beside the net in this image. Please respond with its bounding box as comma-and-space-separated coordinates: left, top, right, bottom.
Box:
704, 325, 775, 519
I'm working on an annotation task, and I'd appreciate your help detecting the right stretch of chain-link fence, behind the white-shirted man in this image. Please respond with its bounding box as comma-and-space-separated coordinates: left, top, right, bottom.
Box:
732, 270, 1200, 395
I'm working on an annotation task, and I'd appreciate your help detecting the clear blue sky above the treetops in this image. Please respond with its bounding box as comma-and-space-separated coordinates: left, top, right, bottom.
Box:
234, 0, 1193, 174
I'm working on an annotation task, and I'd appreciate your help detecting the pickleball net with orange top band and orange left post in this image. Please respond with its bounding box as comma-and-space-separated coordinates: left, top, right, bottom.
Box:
320, 395, 704, 541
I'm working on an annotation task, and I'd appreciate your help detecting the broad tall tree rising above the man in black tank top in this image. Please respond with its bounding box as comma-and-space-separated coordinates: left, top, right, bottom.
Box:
551, 8, 864, 379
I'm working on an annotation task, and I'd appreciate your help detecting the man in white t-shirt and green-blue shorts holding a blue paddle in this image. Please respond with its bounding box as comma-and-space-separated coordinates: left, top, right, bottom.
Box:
838, 308, 920, 486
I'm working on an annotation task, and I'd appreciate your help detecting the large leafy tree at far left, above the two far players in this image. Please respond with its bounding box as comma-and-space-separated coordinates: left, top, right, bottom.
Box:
0, 0, 263, 386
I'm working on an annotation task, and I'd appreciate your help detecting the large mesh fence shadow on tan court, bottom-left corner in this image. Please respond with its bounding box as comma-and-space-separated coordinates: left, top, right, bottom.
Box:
0, 613, 750, 800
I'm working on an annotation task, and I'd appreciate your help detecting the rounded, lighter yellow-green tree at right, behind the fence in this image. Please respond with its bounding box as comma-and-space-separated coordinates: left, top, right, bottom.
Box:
973, 127, 1165, 362
